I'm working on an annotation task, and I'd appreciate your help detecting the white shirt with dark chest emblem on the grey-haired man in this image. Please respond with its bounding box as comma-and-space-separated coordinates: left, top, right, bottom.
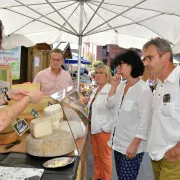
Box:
148, 66, 180, 161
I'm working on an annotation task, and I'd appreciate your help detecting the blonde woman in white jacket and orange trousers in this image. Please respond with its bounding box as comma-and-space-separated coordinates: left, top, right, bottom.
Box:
84, 65, 113, 180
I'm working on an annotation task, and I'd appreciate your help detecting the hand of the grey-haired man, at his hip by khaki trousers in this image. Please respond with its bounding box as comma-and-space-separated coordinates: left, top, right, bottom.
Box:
164, 142, 180, 162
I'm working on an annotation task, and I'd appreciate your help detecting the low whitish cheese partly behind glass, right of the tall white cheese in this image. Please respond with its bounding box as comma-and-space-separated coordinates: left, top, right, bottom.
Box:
59, 121, 85, 139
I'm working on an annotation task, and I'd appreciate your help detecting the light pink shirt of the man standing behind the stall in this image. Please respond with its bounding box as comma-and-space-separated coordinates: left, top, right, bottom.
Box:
33, 67, 73, 95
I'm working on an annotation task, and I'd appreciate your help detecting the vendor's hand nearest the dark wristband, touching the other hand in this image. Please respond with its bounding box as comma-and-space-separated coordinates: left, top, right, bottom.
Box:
6, 89, 28, 101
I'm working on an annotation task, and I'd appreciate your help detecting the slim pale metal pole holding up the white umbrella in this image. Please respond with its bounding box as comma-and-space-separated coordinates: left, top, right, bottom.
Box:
77, 1, 84, 92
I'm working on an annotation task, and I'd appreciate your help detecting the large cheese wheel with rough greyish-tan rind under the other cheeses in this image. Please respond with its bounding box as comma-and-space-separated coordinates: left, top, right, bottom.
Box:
26, 129, 76, 157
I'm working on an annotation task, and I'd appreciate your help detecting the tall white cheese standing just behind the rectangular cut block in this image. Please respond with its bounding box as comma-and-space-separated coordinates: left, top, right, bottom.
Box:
44, 104, 63, 129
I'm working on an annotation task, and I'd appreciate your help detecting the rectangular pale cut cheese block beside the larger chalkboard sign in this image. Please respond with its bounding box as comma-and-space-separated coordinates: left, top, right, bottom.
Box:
30, 116, 53, 138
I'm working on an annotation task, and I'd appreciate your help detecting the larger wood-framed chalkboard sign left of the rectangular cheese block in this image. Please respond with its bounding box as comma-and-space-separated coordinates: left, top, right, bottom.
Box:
12, 118, 29, 136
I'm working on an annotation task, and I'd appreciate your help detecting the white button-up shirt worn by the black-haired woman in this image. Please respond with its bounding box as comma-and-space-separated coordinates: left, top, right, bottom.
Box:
108, 80, 153, 154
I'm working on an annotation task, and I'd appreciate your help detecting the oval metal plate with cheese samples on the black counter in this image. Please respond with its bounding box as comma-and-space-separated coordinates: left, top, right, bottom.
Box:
43, 157, 74, 168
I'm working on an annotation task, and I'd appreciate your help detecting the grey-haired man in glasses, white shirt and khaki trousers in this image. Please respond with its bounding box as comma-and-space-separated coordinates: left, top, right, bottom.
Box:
143, 38, 180, 180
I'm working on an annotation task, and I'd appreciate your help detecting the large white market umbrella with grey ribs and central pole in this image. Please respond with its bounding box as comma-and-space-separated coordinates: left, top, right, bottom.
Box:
0, 0, 180, 88
